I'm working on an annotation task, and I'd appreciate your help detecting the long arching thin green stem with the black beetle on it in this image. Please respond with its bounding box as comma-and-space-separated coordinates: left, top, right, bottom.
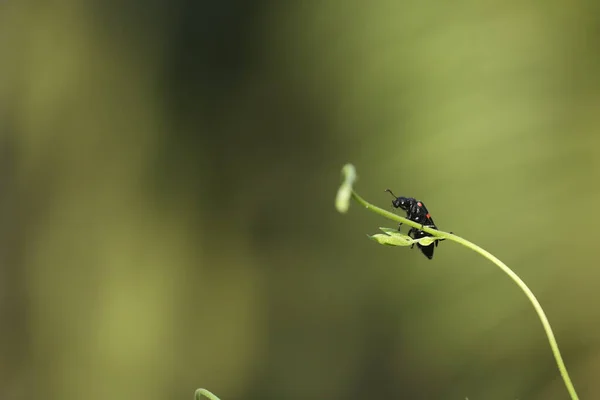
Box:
352, 190, 579, 400
